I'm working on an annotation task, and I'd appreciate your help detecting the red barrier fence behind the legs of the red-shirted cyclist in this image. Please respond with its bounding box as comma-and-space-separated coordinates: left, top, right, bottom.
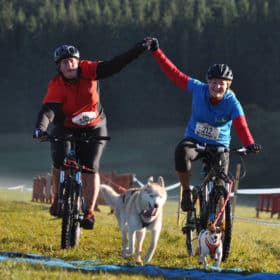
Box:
32, 172, 134, 208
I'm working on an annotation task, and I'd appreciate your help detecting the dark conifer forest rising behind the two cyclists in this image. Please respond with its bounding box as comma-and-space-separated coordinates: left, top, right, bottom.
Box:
0, 0, 280, 184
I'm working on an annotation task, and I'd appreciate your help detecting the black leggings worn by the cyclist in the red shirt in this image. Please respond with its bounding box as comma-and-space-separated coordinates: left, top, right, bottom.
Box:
51, 120, 108, 172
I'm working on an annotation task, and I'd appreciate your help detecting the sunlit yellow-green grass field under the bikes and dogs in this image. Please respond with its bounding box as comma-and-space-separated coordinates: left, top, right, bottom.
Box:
0, 189, 280, 279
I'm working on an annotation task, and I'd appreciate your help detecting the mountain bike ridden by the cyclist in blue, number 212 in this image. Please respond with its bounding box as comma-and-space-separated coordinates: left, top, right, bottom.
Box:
182, 144, 248, 261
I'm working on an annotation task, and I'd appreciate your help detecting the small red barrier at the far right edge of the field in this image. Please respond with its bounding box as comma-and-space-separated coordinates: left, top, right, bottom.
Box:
256, 194, 280, 219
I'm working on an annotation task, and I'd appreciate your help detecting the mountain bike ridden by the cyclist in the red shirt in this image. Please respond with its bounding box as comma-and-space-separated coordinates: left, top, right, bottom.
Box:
48, 134, 110, 249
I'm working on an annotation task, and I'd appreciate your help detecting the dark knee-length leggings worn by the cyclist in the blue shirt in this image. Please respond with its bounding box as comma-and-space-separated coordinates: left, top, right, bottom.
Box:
175, 138, 229, 174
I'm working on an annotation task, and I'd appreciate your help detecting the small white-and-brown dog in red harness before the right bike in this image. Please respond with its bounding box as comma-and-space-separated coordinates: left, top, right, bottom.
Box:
198, 226, 223, 268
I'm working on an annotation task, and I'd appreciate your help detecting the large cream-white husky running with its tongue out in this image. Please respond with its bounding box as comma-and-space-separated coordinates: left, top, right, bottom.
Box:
100, 177, 167, 264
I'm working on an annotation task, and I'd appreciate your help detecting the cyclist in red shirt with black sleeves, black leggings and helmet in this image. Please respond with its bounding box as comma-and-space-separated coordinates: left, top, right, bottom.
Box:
33, 40, 147, 229
